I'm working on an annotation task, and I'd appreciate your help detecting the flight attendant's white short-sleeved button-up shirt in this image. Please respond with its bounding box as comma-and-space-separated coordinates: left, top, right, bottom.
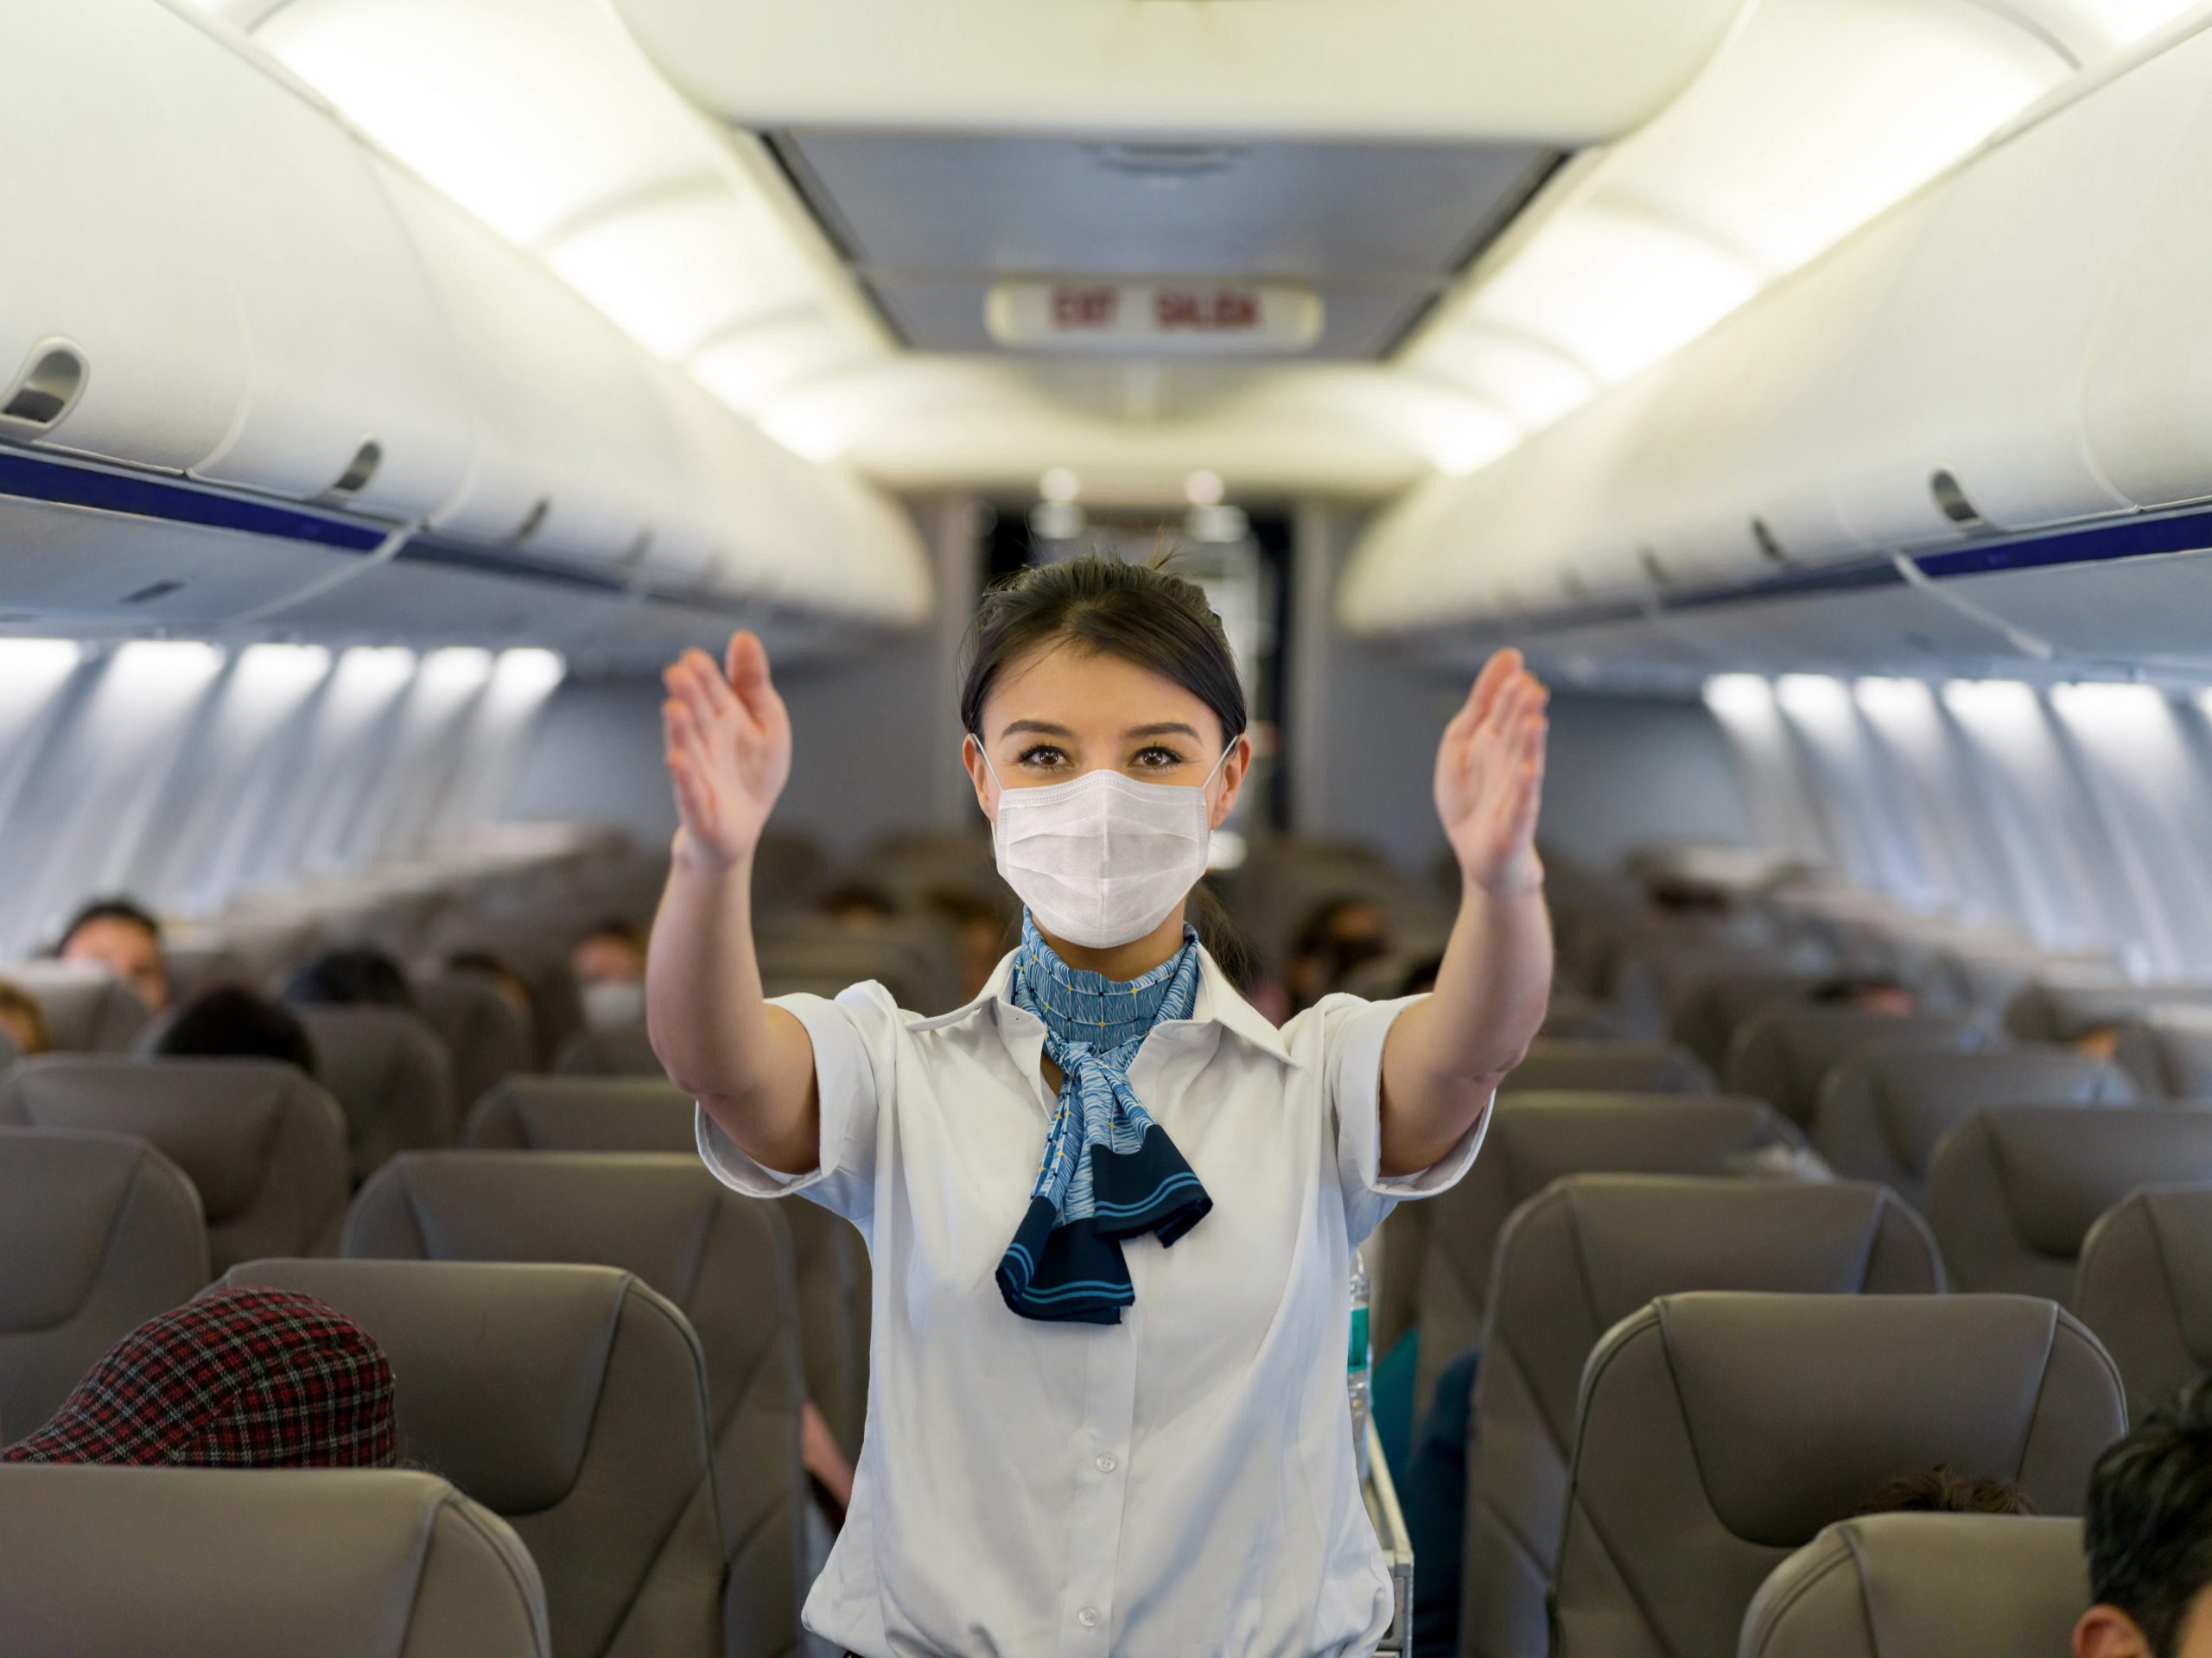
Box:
699, 957, 1489, 1658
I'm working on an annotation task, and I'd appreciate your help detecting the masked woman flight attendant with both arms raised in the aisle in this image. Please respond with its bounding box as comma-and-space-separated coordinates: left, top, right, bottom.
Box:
648, 557, 1551, 1658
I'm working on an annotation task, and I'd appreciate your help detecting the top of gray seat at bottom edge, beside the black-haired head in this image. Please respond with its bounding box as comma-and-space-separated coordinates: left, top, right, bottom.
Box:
1737, 1515, 2090, 1658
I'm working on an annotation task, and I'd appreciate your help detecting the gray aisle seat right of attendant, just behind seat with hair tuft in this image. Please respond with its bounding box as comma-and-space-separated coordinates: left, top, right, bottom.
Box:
1460, 1174, 1942, 1658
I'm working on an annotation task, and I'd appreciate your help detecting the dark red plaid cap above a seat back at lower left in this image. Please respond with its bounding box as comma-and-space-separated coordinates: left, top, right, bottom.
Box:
0, 1289, 398, 1468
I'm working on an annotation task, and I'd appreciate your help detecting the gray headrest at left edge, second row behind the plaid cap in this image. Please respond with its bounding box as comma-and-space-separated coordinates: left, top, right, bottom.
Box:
0, 1054, 339, 1225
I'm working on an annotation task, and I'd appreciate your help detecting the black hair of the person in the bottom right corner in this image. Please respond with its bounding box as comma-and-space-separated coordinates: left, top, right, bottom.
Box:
2082, 1377, 2212, 1658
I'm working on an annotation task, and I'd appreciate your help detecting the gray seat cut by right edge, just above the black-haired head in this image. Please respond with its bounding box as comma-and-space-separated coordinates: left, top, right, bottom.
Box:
2075, 1185, 2212, 1421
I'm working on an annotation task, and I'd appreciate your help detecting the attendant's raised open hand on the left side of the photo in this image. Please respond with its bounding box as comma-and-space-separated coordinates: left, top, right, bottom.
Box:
661, 632, 791, 871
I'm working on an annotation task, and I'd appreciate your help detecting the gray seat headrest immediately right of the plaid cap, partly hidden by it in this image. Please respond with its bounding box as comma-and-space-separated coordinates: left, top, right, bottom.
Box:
217, 1260, 637, 1515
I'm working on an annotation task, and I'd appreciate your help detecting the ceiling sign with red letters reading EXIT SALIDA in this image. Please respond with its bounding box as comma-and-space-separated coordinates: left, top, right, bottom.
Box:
984, 278, 1320, 356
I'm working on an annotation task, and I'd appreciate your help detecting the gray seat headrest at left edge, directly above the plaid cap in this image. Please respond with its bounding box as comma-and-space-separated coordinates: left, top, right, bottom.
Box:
0, 1128, 208, 1335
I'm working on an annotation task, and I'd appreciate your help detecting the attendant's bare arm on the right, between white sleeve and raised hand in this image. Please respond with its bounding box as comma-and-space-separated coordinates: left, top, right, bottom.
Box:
1382, 882, 1551, 1174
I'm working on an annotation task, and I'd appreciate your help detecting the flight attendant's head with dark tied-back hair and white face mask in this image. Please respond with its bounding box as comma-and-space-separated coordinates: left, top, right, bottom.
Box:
960, 557, 1252, 942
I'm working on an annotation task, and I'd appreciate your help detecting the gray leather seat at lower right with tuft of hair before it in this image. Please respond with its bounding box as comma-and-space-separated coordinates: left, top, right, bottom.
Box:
1551, 1293, 2126, 1658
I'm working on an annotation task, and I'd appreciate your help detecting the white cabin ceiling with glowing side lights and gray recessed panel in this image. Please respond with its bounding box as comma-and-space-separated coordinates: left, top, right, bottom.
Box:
190, 0, 2183, 499
